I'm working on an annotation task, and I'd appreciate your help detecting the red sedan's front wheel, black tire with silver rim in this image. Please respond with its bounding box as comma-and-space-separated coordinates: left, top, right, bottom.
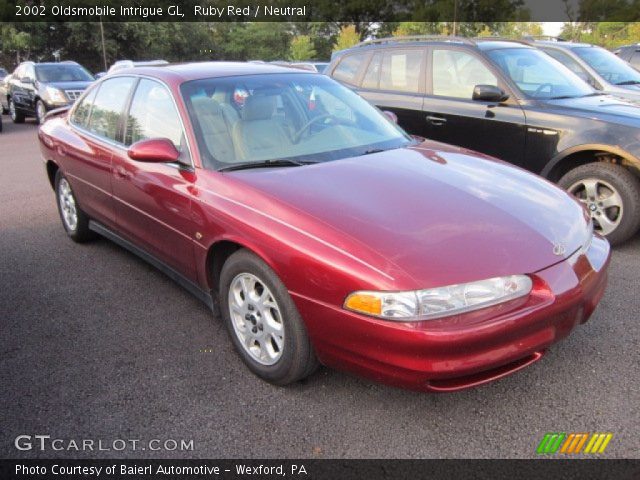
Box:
220, 249, 319, 385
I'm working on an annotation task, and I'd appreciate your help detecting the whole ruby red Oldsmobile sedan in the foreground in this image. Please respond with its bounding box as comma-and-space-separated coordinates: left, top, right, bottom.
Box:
39, 63, 609, 392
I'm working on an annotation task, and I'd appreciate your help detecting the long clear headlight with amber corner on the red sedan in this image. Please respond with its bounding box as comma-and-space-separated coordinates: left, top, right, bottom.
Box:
344, 275, 532, 322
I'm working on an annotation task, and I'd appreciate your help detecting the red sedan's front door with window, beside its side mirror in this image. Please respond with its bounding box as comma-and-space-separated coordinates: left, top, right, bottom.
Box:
112, 78, 196, 279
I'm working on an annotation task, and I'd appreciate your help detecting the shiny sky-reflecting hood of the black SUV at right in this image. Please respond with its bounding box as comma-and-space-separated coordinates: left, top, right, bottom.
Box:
545, 92, 640, 127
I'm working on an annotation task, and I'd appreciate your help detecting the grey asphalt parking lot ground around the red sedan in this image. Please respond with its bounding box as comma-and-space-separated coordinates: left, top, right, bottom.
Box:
0, 116, 640, 458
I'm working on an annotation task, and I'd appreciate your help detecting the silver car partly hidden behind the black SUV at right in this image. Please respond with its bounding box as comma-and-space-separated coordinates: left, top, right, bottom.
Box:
531, 40, 640, 103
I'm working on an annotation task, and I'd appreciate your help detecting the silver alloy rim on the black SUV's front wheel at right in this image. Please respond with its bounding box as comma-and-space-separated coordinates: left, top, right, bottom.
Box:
569, 178, 624, 235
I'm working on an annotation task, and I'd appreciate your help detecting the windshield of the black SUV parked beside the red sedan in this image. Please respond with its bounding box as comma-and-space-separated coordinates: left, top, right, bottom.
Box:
487, 48, 595, 99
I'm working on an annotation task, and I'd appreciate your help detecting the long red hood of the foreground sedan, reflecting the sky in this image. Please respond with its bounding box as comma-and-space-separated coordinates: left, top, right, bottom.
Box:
229, 143, 587, 288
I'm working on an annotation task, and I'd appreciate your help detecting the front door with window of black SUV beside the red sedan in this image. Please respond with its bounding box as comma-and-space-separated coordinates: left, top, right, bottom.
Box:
422, 46, 526, 164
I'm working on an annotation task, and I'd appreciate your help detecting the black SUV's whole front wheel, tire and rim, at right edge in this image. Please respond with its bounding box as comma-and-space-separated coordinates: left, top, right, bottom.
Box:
558, 162, 640, 245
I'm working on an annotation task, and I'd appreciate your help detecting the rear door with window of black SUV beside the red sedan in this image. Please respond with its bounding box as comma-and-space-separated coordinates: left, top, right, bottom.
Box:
359, 47, 426, 136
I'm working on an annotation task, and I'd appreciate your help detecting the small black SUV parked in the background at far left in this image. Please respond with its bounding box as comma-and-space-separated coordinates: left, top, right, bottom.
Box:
6, 62, 94, 123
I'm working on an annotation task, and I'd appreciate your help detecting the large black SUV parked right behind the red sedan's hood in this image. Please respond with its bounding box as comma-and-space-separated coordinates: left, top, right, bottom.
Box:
325, 37, 640, 244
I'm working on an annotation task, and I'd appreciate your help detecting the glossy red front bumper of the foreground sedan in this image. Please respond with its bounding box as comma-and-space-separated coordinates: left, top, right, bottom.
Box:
292, 236, 610, 392
